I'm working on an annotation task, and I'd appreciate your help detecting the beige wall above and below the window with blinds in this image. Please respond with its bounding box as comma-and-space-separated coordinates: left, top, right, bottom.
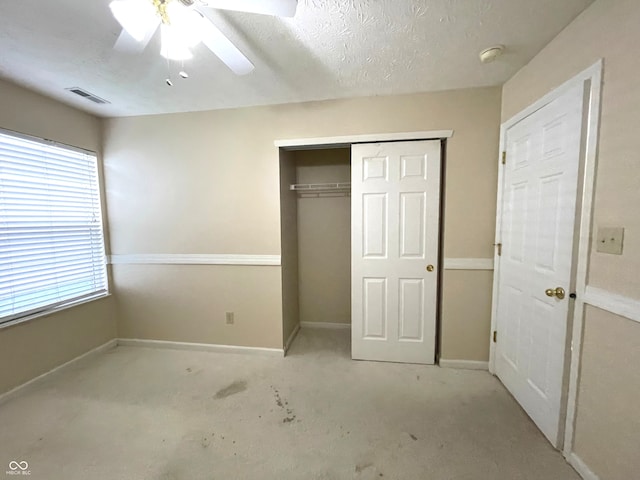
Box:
0, 80, 116, 393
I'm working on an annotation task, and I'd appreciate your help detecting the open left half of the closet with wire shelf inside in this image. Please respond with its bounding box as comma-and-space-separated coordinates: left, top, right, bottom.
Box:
280, 145, 351, 358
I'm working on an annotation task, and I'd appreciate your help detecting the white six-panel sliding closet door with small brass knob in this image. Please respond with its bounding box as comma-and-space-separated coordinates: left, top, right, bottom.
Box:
351, 140, 441, 364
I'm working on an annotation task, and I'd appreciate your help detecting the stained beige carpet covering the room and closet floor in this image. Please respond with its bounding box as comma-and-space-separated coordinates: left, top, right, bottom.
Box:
0, 330, 579, 480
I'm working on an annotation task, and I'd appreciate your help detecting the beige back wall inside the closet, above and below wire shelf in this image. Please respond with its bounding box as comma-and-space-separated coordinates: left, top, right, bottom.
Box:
295, 148, 351, 323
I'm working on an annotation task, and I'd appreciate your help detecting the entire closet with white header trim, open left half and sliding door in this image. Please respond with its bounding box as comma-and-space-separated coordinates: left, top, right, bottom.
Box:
274, 130, 453, 365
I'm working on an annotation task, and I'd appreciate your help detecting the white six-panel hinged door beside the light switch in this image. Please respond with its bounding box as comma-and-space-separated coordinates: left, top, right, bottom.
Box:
495, 86, 583, 446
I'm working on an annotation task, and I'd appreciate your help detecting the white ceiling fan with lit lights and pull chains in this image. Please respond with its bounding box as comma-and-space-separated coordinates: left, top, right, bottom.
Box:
109, 0, 298, 75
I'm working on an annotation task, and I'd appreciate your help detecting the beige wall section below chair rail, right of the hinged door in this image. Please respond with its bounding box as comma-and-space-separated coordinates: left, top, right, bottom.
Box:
574, 307, 640, 480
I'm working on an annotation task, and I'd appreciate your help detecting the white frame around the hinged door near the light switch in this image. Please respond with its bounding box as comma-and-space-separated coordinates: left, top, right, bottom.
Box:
489, 59, 603, 458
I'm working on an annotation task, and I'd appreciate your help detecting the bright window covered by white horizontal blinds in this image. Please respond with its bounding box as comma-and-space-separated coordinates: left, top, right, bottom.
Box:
0, 131, 107, 323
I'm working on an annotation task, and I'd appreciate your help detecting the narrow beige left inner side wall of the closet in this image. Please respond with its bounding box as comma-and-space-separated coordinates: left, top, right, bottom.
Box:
280, 150, 300, 345
